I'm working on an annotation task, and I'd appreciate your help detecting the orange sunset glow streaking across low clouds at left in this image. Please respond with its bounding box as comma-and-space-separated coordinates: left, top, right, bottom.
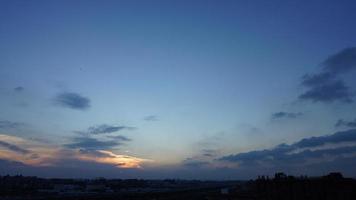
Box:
0, 134, 151, 168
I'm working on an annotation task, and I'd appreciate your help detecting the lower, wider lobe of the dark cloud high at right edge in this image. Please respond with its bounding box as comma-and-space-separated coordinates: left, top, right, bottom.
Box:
299, 80, 353, 103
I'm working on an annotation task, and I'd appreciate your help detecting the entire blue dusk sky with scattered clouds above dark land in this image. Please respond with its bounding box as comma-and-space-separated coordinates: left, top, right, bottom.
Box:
0, 0, 356, 180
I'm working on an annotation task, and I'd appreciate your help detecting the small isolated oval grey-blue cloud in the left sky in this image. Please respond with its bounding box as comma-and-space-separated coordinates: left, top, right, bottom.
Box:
54, 92, 90, 110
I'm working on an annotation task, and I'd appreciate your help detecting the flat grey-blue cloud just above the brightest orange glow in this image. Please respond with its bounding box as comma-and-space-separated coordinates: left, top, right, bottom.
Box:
64, 137, 121, 150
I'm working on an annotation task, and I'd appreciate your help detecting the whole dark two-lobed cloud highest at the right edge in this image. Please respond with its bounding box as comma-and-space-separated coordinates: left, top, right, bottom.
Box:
299, 47, 356, 103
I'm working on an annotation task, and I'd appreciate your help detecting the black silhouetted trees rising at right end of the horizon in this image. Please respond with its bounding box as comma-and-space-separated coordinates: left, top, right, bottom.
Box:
250, 173, 356, 200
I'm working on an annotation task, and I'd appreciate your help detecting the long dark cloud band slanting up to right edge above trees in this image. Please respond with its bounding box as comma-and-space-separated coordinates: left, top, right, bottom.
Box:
219, 129, 356, 166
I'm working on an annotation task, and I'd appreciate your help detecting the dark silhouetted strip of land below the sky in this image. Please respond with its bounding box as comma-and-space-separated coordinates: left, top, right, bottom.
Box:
0, 173, 356, 200
